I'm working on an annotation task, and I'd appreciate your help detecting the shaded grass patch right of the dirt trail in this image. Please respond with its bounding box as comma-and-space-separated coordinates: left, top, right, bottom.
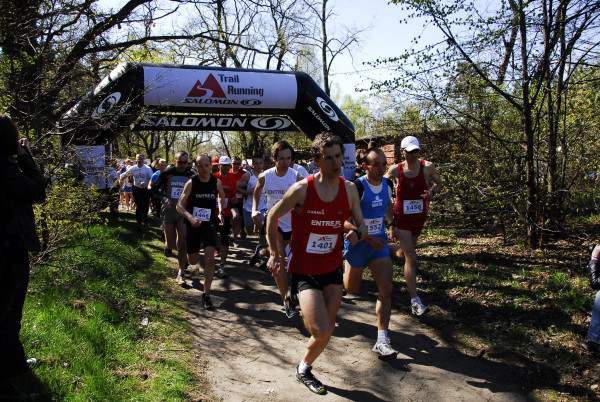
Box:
394, 222, 600, 400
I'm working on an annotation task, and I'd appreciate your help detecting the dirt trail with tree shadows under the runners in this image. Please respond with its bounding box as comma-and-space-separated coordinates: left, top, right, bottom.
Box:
177, 239, 526, 402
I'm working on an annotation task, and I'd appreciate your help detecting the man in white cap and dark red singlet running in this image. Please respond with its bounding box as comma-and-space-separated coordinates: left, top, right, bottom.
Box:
385, 136, 442, 316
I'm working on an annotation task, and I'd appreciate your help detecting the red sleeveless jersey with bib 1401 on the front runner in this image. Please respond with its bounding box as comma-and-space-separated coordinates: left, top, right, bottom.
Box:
288, 175, 350, 275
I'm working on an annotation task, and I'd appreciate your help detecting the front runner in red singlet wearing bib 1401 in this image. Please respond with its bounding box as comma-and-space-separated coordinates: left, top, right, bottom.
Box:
267, 133, 376, 394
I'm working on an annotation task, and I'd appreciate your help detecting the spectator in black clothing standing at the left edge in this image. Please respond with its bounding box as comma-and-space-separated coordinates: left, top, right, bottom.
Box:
0, 115, 46, 399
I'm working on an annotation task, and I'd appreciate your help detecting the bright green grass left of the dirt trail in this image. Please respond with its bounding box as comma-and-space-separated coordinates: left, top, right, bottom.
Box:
19, 214, 201, 401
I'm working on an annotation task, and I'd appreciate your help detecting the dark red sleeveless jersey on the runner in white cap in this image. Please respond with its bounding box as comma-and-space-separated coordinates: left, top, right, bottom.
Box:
394, 160, 429, 219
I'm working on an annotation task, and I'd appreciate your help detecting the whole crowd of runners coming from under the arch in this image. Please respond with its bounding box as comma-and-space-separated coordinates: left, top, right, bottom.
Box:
113, 132, 442, 394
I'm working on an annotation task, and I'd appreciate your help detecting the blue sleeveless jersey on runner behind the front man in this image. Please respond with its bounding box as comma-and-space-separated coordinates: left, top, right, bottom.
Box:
356, 176, 390, 236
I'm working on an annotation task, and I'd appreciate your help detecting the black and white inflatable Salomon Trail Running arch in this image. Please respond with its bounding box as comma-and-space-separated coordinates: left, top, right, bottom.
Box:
59, 63, 355, 182
